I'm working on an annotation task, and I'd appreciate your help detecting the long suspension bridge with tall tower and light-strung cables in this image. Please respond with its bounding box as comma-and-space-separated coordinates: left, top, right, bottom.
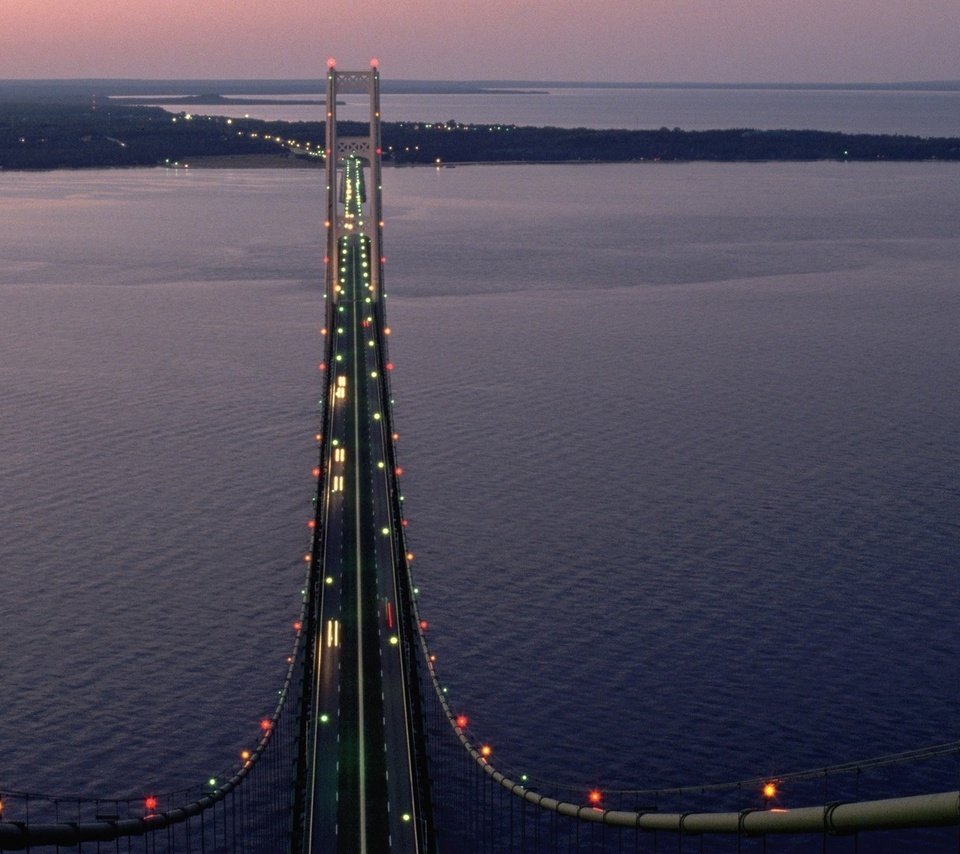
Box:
0, 61, 960, 854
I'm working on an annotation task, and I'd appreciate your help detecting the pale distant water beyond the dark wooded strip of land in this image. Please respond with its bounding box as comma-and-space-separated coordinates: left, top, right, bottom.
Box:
133, 88, 960, 136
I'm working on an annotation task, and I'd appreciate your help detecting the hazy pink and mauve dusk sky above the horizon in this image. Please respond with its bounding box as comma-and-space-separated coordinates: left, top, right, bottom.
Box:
0, 0, 960, 83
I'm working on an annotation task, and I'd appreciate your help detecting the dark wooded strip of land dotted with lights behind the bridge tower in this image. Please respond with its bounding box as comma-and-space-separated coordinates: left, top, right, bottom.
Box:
0, 101, 960, 170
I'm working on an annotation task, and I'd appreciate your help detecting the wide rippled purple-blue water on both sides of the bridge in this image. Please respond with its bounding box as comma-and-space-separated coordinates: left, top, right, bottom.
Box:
0, 163, 960, 852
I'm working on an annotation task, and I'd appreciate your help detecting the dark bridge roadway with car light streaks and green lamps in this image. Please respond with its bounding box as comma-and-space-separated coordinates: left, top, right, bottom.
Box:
303, 164, 421, 852
